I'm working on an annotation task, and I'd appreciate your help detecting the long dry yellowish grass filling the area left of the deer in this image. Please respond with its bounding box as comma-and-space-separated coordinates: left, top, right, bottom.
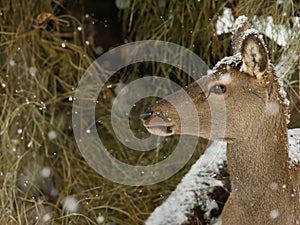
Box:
0, 0, 205, 225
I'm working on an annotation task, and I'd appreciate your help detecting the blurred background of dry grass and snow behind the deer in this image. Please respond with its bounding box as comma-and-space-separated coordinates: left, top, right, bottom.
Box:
0, 0, 300, 225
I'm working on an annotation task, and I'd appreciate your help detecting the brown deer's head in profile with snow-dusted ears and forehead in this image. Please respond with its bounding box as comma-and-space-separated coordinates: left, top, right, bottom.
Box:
143, 17, 284, 141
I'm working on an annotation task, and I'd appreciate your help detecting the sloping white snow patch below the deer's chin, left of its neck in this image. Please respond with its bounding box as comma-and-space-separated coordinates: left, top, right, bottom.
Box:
145, 142, 226, 225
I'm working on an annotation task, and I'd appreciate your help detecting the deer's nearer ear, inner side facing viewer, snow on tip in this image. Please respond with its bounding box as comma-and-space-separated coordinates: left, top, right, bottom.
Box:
241, 29, 269, 79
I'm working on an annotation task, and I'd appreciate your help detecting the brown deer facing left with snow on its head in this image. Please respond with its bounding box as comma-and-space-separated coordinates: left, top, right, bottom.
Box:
142, 16, 300, 225
